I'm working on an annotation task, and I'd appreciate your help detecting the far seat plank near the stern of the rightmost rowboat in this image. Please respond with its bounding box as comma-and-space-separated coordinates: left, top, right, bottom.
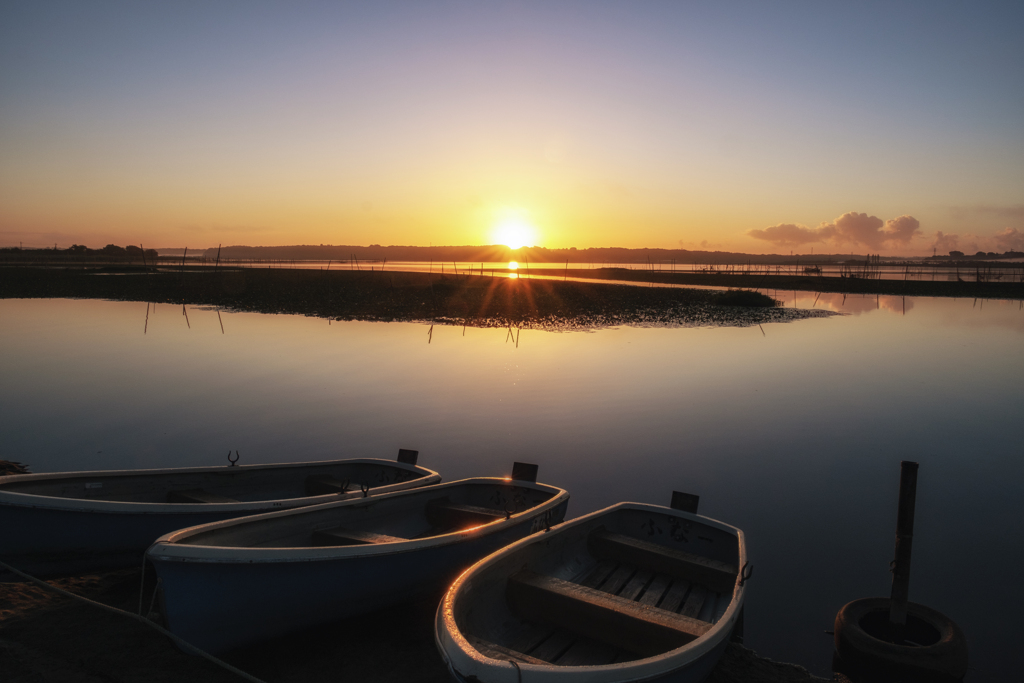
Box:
587, 526, 738, 593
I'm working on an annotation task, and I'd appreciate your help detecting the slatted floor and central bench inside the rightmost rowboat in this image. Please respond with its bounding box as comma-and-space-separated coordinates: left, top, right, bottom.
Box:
466, 531, 734, 667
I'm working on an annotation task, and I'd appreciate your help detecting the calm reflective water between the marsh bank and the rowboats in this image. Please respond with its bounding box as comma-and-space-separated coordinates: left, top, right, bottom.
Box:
0, 293, 1024, 681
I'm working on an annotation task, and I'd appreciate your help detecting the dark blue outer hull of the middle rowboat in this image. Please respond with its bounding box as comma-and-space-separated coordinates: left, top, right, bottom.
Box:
147, 480, 568, 652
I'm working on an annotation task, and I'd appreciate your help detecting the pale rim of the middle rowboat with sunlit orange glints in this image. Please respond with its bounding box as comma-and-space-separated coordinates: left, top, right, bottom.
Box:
145, 477, 569, 564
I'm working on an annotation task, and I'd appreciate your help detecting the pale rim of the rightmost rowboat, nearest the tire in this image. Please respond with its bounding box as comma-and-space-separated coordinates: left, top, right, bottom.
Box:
434, 502, 748, 683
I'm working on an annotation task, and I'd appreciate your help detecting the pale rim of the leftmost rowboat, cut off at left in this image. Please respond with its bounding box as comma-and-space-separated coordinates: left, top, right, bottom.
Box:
0, 458, 441, 515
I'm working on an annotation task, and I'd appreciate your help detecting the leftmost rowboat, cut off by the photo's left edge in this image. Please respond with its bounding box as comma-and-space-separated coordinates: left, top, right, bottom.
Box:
0, 449, 440, 581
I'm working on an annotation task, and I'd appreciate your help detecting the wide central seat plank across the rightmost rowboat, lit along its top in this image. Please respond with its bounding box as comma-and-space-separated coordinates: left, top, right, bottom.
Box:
506, 569, 711, 656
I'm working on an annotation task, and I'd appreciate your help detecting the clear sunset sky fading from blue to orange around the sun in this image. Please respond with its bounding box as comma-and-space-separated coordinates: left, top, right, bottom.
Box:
0, 0, 1024, 255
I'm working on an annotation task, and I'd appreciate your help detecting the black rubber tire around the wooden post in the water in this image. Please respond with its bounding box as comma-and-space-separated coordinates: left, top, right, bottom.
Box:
835, 598, 968, 681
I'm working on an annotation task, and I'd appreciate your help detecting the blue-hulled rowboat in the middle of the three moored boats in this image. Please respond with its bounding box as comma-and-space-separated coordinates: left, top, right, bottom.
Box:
146, 466, 568, 652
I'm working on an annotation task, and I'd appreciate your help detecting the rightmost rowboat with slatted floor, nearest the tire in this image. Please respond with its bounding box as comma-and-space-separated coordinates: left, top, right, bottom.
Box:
434, 495, 752, 683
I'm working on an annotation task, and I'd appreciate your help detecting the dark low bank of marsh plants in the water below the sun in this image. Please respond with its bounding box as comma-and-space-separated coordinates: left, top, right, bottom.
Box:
0, 267, 829, 329
